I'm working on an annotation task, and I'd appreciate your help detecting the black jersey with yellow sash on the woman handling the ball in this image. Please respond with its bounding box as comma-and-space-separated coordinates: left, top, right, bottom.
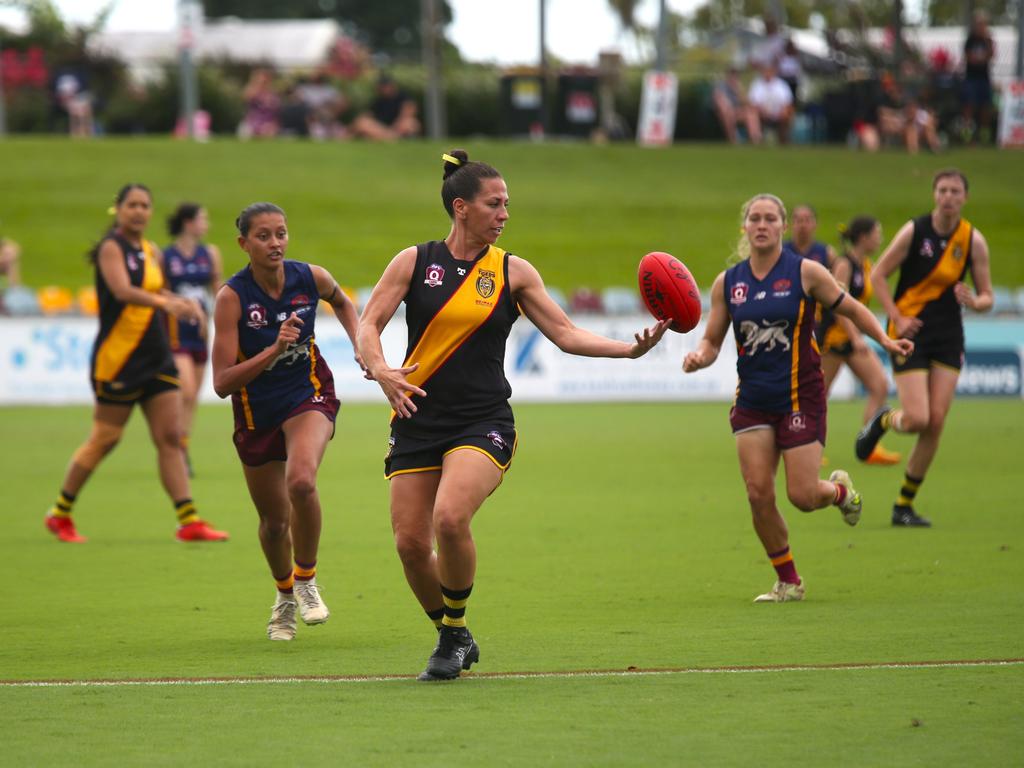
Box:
392, 241, 519, 436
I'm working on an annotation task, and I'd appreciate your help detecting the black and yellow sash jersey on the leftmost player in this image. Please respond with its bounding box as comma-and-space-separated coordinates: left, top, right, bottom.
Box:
92, 234, 174, 391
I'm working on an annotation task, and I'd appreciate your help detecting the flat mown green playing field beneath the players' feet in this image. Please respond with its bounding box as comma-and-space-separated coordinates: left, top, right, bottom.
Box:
0, 399, 1024, 766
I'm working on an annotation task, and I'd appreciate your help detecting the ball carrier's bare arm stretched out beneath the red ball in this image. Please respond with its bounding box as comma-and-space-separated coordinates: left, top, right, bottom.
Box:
509, 256, 672, 358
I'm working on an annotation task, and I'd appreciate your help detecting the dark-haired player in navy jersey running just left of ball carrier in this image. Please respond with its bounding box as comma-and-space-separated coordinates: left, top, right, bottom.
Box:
213, 203, 358, 640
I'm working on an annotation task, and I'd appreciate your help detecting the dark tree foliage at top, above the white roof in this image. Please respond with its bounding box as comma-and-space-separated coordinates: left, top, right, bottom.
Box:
202, 0, 452, 54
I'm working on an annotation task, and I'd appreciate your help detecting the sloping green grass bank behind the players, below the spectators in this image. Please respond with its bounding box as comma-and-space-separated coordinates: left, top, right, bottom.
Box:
0, 138, 1024, 291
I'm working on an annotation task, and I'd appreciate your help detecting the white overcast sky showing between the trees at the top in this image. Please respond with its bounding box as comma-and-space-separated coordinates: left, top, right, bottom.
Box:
0, 0, 701, 65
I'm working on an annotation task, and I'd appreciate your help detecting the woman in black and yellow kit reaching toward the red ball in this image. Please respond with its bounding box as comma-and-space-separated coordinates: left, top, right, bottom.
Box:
359, 150, 669, 680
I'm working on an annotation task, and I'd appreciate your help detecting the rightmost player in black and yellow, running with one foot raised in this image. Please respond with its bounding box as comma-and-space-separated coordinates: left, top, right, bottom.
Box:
856, 168, 993, 527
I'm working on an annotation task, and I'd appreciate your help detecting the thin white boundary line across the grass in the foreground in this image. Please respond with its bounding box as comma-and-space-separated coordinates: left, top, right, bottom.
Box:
0, 658, 1024, 688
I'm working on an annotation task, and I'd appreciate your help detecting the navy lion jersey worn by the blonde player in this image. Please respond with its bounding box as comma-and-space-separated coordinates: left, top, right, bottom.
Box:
724, 249, 824, 413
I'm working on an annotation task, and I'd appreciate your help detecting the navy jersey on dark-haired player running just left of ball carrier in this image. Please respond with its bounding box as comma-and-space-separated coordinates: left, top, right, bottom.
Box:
226, 260, 334, 430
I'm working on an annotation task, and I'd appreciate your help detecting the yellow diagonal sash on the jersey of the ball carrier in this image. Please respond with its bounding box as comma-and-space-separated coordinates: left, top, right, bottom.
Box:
403, 246, 505, 387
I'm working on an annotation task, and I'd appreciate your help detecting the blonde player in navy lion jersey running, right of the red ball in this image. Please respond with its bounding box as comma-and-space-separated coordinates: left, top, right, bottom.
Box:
683, 195, 913, 602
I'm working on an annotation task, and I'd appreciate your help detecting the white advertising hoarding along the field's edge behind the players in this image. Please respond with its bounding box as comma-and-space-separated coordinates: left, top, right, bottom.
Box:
0, 315, 868, 404
